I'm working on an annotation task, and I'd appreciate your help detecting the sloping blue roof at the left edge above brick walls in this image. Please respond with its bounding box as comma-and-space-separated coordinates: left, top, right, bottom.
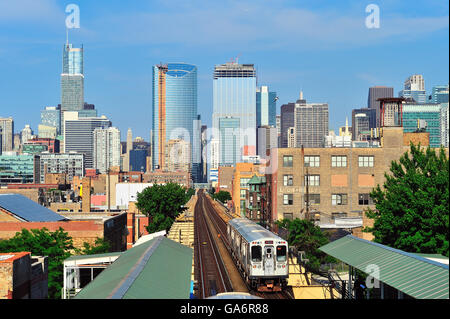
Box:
0, 194, 66, 222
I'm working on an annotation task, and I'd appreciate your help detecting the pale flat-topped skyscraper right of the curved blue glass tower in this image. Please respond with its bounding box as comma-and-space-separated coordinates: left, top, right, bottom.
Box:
212, 62, 257, 165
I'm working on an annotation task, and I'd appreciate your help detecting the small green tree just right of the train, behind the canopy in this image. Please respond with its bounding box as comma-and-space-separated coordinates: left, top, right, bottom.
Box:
276, 218, 336, 272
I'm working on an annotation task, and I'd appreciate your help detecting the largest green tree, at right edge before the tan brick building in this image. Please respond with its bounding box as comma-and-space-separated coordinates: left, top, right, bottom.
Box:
364, 144, 449, 257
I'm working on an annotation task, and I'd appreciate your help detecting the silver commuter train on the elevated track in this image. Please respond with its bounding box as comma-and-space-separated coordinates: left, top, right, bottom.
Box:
227, 218, 289, 292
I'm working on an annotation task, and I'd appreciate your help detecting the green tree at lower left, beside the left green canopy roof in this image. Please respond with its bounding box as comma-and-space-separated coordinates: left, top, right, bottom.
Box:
0, 227, 74, 299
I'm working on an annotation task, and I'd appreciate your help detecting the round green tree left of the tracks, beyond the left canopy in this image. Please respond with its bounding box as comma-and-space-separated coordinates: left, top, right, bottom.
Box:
136, 183, 186, 233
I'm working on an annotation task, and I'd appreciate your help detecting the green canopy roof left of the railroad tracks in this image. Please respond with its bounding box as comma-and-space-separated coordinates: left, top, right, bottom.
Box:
75, 236, 193, 299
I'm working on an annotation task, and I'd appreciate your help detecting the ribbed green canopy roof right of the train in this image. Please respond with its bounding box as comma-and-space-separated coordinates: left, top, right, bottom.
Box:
319, 235, 449, 299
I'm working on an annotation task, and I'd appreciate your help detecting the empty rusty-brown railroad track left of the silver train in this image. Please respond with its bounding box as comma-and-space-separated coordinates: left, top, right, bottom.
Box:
194, 191, 232, 299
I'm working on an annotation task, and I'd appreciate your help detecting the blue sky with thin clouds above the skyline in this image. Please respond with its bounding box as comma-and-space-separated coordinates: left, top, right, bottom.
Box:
0, 0, 449, 140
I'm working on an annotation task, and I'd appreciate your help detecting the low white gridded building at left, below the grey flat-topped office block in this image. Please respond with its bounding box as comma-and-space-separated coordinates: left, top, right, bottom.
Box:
39, 153, 85, 183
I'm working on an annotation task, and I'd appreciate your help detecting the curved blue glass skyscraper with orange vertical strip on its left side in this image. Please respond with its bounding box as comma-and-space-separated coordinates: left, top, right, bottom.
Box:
152, 63, 200, 181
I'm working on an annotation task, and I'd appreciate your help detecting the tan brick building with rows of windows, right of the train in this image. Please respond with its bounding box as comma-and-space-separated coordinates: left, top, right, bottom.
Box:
266, 127, 448, 228
